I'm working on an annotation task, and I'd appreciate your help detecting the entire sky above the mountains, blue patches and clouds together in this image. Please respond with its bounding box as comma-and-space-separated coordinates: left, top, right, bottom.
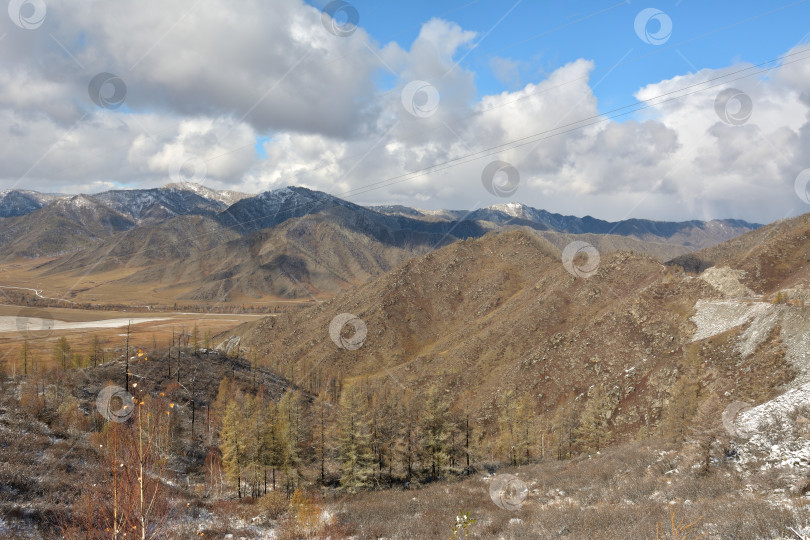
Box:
0, 0, 810, 222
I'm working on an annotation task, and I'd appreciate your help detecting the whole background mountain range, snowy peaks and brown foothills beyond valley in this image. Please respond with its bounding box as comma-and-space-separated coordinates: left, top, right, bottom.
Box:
0, 183, 759, 303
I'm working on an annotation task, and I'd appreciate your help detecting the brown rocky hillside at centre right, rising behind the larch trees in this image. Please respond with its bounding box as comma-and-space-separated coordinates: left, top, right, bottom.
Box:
230, 216, 810, 446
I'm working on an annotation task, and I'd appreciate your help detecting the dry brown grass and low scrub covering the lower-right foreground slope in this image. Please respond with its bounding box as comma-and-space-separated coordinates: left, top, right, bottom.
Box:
298, 438, 810, 540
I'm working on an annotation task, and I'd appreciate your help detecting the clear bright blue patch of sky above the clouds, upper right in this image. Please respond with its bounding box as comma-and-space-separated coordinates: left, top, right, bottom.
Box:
313, 0, 810, 112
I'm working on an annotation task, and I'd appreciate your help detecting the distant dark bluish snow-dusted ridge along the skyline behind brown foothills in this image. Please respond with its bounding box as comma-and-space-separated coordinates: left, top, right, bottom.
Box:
0, 182, 761, 250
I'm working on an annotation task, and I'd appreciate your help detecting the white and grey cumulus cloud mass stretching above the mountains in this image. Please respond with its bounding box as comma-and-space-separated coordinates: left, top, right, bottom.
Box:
0, 0, 810, 222
